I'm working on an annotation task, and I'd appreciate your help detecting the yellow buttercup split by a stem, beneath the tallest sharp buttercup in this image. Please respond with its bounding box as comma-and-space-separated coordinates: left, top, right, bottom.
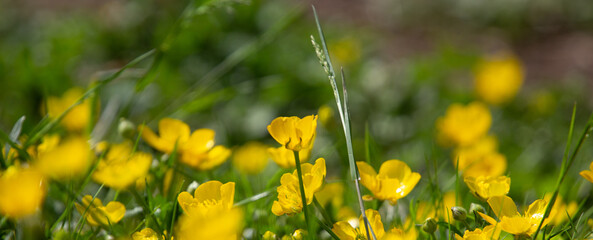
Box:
272, 158, 326, 216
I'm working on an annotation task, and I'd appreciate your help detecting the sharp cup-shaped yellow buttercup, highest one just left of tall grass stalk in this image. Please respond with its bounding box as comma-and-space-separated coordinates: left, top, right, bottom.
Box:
268, 115, 317, 151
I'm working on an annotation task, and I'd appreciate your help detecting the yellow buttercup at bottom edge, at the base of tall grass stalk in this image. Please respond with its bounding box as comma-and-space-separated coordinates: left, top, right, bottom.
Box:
332, 209, 385, 240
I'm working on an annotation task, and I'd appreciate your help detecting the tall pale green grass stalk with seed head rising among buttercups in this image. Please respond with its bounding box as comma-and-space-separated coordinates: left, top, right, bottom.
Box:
311, 6, 377, 239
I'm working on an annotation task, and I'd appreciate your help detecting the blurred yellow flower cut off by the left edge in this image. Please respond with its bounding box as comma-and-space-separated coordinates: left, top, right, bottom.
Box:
0, 166, 47, 218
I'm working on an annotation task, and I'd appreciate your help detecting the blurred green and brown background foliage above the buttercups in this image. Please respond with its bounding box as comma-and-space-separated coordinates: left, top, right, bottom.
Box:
0, 0, 593, 202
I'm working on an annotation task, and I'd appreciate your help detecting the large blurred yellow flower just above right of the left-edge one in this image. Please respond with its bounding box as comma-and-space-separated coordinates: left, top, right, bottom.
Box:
34, 136, 93, 180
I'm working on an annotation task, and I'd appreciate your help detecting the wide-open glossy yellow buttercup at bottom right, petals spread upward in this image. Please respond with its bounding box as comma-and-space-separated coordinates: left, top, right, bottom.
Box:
479, 196, 555, 236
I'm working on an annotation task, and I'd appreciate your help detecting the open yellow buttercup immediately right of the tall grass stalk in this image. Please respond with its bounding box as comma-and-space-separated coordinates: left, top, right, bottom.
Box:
356, 160, 420, 204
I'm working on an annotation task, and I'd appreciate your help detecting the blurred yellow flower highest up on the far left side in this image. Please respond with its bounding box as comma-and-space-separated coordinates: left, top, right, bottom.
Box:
47, 88, 91, 131
